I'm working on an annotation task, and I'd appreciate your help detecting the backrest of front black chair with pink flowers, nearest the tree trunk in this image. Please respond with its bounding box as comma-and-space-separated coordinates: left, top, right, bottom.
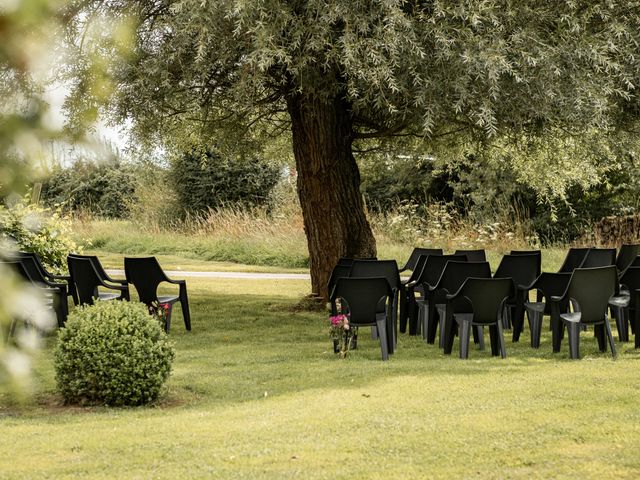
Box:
331, 277, 392, 325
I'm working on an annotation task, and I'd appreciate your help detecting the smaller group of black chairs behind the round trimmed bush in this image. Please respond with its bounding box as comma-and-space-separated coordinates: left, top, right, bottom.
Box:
5, 252, 191, 332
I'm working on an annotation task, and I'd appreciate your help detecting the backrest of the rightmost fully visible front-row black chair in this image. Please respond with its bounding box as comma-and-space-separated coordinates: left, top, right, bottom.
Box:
567, 265, 618, 323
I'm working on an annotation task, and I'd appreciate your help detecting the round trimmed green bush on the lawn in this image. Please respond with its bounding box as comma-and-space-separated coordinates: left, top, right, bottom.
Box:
54, 301, 174, 405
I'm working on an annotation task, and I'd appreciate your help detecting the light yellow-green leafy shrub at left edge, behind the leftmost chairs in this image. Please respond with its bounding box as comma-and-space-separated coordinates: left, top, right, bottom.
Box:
0, 197, 81, 272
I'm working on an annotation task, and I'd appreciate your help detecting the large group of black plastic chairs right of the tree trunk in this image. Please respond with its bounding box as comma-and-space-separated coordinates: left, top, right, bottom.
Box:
328, 245, 640, 359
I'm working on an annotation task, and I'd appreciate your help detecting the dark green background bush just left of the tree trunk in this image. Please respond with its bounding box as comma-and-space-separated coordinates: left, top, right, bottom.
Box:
170, 151, 280, 213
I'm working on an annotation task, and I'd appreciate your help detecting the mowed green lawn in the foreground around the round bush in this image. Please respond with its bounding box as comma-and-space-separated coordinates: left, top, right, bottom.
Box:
0, 280, 640, 479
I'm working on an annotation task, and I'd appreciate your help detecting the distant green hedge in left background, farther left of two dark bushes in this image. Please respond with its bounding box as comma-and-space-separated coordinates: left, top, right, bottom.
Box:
42, 160, 136, 218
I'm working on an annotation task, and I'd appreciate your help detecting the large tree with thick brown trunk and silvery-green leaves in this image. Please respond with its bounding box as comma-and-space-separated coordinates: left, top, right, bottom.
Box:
66, 0, 640, 297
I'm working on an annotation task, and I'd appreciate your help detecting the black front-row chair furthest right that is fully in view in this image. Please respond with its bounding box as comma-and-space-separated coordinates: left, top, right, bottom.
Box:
551, 265, 618, 359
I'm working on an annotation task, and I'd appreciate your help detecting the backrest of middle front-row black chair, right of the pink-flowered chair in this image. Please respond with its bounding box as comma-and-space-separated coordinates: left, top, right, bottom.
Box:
454, 277, 513, 323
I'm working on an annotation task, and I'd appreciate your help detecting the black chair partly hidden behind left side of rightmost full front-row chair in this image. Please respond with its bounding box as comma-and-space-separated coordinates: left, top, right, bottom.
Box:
524, 272, 571, 348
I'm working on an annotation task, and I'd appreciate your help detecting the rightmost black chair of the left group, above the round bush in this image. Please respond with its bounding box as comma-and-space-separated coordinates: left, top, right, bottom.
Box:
124, 257, 191, 333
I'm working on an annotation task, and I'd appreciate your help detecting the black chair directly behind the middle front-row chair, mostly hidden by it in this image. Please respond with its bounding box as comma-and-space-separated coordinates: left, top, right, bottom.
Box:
423, 261, 491, 353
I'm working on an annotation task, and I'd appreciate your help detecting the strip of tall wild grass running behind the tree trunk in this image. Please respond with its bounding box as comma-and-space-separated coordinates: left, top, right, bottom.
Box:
73, 193, 555, 268
